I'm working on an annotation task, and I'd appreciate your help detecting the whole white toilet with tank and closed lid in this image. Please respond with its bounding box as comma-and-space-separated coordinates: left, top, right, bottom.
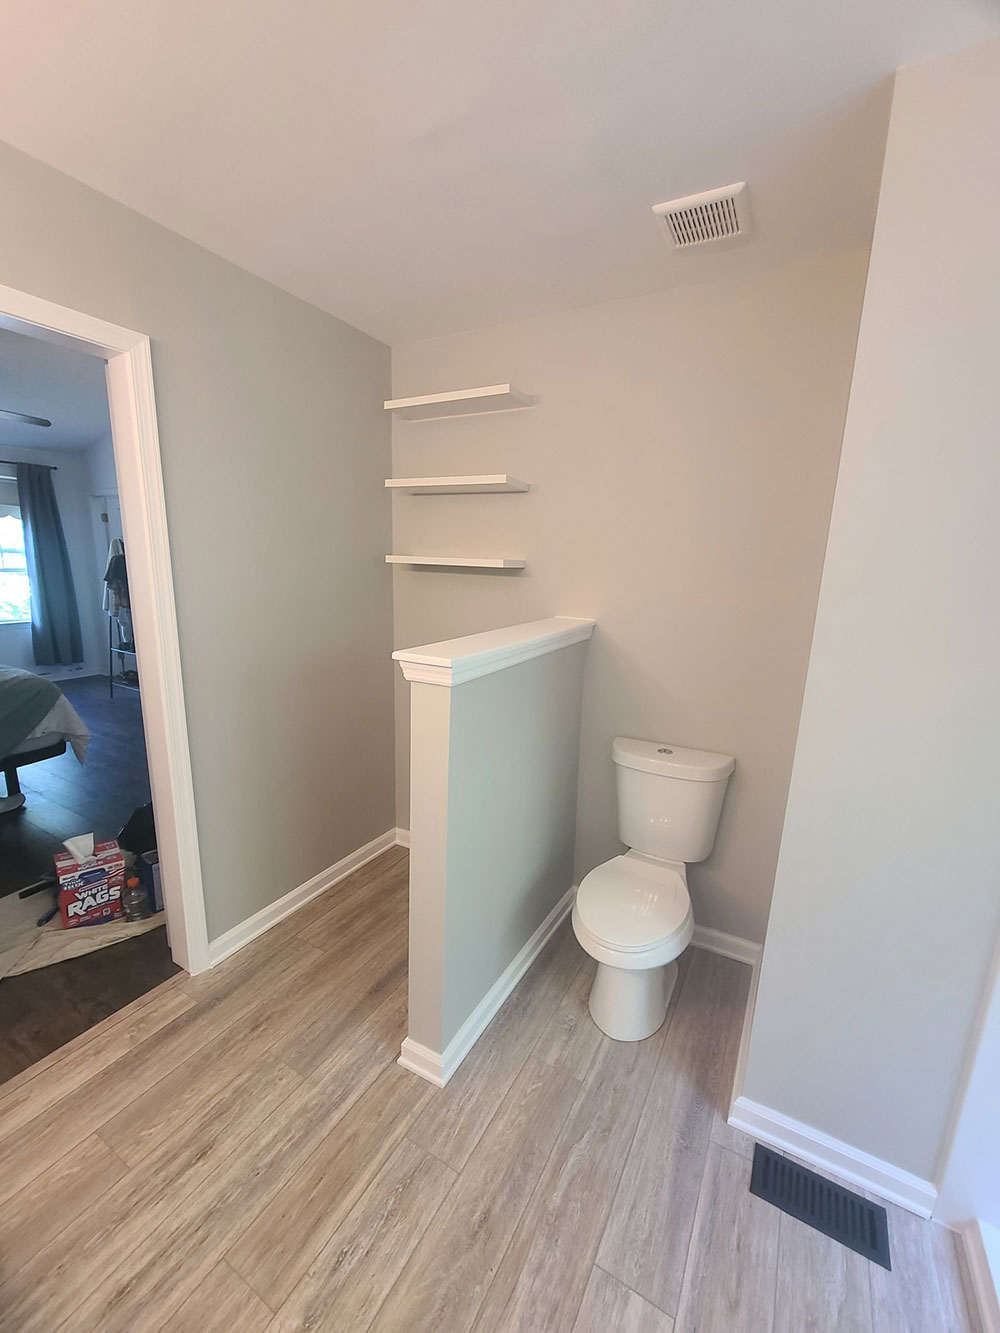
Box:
573, 736, 736, 1041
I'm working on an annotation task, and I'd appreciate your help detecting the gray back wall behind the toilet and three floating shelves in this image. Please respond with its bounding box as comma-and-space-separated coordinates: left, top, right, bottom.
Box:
393, 253, 867, 940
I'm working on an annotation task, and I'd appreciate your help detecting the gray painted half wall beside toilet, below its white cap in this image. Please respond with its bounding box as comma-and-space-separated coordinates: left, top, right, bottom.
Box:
407, 643, 588, 1053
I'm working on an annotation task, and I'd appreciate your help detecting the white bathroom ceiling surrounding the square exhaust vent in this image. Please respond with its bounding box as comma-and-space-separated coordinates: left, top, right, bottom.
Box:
0, 0, 1000, 341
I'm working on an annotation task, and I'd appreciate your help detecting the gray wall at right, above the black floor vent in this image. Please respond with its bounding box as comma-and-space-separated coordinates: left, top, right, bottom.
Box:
744, 43, 1000, 1181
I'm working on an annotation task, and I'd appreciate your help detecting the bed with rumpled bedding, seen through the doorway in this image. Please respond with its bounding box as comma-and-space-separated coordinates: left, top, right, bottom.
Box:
0, 667, 91, 814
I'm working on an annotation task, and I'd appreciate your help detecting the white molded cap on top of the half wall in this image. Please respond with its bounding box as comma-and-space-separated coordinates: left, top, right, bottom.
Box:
392, 616, 596, 689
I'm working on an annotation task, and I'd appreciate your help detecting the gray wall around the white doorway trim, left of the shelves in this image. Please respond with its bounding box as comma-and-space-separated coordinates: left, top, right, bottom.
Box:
0, 137, 393, 937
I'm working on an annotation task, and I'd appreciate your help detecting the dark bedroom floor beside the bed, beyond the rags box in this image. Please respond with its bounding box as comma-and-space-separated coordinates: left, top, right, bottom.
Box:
0, 676, 149, 897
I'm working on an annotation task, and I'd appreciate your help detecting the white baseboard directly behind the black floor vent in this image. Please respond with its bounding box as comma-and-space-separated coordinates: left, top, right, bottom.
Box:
729, 1097, 937, 1217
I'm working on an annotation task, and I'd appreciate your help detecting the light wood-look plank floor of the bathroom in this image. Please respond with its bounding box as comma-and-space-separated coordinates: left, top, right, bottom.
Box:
0, 850, 975, 1333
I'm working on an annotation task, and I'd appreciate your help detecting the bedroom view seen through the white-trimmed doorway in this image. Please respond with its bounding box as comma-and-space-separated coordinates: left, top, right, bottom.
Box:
0, 328, 179, 1084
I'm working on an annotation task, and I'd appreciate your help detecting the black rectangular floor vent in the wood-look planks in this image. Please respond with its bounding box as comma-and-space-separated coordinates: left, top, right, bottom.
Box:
751, 1144, 892, 1269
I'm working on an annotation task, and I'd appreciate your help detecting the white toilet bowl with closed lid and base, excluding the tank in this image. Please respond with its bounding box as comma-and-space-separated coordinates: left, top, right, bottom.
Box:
573, 852, 695, 1041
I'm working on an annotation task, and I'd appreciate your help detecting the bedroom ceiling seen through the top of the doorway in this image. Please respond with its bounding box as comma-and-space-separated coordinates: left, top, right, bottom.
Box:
0, 329, 111, 453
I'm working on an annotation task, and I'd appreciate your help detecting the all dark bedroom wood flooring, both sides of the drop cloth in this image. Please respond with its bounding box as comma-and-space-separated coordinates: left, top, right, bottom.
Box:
0, 676, 180, 1084
